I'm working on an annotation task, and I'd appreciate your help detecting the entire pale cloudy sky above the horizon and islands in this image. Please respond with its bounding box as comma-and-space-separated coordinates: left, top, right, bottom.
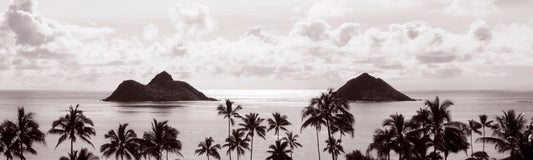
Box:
0, 0, 533, 91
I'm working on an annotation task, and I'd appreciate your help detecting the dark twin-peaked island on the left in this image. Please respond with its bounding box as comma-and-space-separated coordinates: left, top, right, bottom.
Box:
103, 71, 216, 102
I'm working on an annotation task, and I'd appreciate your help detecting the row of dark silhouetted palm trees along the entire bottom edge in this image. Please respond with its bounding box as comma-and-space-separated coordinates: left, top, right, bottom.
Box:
0, 89, 533, 160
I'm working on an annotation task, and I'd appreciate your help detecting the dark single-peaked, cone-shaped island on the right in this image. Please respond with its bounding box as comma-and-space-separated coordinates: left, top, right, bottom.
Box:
335, 73, 414, 102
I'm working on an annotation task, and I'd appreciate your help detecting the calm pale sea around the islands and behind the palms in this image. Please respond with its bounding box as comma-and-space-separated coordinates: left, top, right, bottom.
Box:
0, 90, 533, 160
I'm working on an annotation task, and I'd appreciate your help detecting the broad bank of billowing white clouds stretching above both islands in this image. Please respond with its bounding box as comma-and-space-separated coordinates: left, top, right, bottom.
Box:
0, 0, 533, 90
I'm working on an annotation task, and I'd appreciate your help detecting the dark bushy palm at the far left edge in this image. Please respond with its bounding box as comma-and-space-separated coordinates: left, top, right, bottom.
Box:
2, 107, 45, 160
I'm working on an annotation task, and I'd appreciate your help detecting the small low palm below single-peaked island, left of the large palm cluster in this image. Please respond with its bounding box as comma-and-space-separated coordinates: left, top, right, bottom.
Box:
367, 129, 394, 160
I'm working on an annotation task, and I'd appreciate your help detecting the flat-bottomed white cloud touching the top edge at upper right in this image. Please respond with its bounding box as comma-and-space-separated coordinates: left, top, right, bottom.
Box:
444, 0, 500, 18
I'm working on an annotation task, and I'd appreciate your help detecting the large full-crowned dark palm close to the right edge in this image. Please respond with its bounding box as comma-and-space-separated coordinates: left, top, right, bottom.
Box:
476, 110, 528, 159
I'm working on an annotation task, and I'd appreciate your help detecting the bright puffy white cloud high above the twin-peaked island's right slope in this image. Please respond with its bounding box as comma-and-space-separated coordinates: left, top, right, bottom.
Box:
168, 3, 215, 38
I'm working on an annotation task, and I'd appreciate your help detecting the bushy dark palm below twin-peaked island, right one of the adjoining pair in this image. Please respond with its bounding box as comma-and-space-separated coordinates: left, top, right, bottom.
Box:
143, 119, 182, 160
